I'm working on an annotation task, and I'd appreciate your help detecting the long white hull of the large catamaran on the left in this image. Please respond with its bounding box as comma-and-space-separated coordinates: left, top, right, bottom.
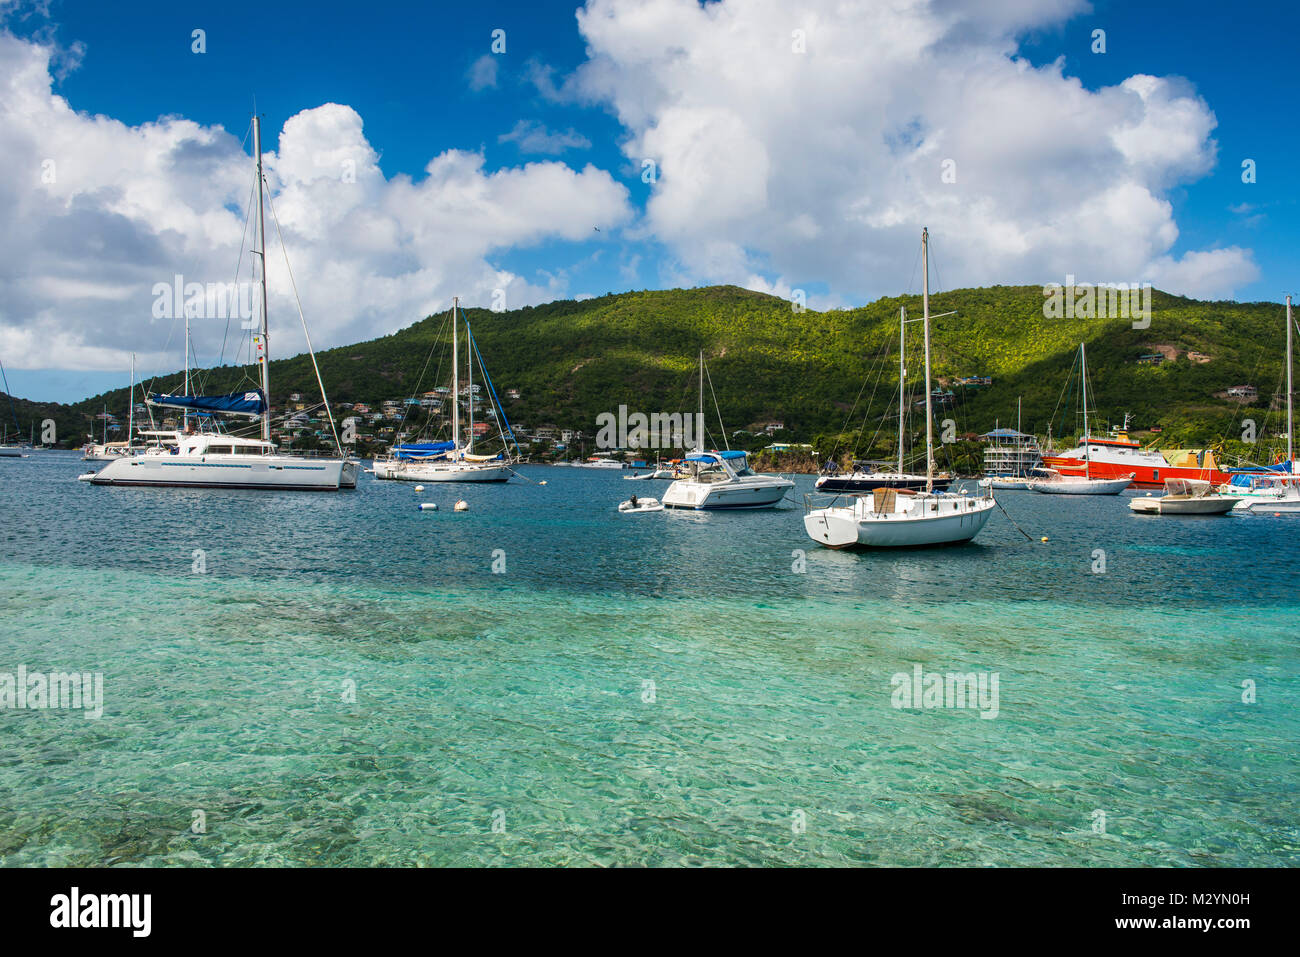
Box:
87, 455, 358, 492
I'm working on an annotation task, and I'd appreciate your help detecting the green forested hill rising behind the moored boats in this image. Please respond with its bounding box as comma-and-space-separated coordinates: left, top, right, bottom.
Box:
18, 286, 1300, 459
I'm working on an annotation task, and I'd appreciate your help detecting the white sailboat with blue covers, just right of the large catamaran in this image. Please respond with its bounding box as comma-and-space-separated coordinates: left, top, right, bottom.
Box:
374, 298, 511, 482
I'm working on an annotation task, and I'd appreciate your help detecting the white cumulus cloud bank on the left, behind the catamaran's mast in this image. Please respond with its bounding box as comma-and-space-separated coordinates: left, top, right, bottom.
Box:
0, 33, 631, 374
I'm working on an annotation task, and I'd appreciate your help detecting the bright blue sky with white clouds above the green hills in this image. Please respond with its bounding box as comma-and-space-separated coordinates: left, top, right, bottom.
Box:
0, 0, 1300, 400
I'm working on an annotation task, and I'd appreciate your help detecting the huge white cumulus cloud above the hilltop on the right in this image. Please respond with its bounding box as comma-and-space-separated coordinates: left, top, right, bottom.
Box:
572, 0, 1257, 300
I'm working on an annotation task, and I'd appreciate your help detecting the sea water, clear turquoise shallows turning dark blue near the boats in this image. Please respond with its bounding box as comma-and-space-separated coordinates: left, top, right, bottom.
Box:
0, 454, 1300, 866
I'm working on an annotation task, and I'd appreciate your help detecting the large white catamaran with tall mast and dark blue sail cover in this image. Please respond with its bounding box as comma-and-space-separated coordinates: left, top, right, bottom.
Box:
79, 116, 359, 492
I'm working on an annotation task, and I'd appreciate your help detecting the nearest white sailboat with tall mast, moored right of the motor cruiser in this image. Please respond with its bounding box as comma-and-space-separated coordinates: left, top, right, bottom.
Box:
803, 229, 997, 549
